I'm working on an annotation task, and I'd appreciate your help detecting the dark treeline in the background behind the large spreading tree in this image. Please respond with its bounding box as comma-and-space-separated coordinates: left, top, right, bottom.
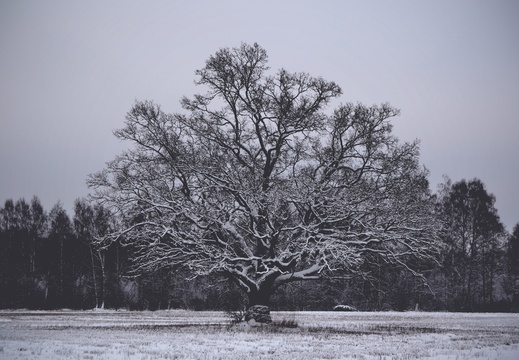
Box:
0, 179, 519, 311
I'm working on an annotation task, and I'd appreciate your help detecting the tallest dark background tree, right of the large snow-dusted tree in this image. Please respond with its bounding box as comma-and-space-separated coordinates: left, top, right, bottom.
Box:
441, 179, 505, 311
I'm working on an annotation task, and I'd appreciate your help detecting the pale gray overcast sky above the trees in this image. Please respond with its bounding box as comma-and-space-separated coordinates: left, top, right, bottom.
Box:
0, 0, 519, 230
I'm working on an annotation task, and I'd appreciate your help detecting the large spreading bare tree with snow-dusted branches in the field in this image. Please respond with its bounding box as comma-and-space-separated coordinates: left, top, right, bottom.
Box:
88, 44, 437, 306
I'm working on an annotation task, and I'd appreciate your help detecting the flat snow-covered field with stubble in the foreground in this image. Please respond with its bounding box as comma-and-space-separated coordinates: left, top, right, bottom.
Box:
0, 310, 519, 360
